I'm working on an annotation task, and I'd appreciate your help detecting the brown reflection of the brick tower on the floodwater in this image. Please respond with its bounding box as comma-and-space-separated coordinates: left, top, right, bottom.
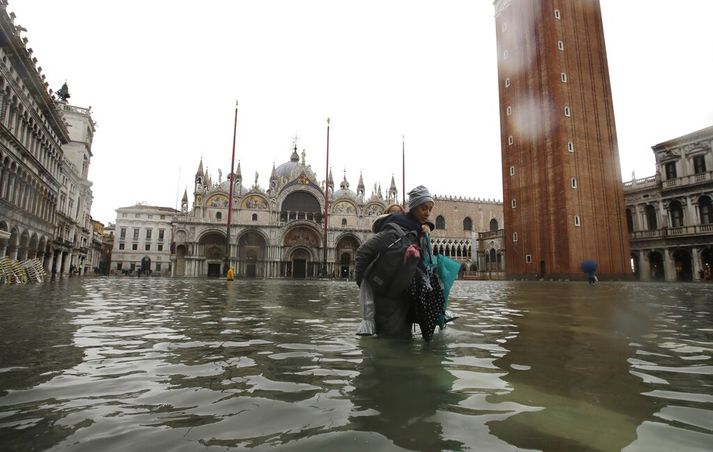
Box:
488, 284, 655, 450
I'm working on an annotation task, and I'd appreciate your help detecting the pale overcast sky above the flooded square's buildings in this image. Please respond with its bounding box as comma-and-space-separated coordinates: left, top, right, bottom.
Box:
8, 0, 713, 223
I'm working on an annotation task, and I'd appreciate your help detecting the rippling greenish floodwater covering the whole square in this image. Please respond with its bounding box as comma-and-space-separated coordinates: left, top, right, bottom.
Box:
0, 278, 713, 452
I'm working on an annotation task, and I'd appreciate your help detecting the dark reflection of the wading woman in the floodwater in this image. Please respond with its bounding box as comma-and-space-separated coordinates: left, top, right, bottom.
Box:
351, 338, 464, 450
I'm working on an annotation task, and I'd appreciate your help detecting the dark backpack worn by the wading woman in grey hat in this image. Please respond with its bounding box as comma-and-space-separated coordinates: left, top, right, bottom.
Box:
365, 223, 418, 297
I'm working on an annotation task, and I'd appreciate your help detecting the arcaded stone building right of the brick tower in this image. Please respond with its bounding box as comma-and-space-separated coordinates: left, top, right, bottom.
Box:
624, 122, 713, 281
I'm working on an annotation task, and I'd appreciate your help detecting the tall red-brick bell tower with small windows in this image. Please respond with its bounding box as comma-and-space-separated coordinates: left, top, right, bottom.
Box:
494, 0, 631, 278
